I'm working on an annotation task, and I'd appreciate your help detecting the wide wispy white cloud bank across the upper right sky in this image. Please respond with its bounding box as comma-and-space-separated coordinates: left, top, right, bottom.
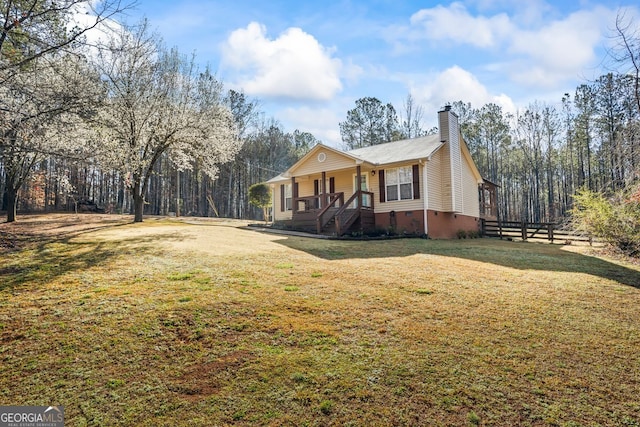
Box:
402, 1, 616, 89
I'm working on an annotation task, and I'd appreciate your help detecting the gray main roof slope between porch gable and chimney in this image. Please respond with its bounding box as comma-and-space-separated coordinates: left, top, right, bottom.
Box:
347, 134, 442, 165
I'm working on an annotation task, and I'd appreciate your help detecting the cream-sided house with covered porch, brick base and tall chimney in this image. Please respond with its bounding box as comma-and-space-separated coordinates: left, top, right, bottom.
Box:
268, 106, 495, 238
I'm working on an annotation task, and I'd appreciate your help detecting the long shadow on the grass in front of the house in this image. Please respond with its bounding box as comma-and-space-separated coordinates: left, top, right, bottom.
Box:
277, 237, 640, 289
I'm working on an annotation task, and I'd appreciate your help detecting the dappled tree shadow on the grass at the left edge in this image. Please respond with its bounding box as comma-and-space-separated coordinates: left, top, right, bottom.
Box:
0, 231, 191, 291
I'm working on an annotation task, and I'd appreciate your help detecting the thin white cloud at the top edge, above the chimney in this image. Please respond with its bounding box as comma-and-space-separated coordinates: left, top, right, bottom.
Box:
410, 2, 512, 48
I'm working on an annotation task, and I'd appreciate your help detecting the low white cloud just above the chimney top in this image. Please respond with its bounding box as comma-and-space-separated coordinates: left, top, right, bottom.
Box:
409, 66, 515, 117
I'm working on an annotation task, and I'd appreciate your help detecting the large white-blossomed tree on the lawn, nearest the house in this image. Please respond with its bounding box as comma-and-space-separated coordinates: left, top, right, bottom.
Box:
91, 21, 240, 222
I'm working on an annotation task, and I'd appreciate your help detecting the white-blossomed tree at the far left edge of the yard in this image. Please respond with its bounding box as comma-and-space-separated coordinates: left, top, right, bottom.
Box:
0, 54, 101, 222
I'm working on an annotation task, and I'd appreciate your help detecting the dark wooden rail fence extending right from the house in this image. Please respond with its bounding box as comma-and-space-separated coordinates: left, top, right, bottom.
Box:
481, 219, 593, 245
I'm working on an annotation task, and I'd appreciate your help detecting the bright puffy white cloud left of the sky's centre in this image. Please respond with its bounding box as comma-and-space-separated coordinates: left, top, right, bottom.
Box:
222, 22, 344, 100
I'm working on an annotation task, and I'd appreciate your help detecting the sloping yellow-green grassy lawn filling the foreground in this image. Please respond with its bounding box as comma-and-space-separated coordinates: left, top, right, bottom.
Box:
0, 216, 640, 426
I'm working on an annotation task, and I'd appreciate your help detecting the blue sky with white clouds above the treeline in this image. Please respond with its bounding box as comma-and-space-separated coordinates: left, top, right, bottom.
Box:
117, 0, 640, 147
